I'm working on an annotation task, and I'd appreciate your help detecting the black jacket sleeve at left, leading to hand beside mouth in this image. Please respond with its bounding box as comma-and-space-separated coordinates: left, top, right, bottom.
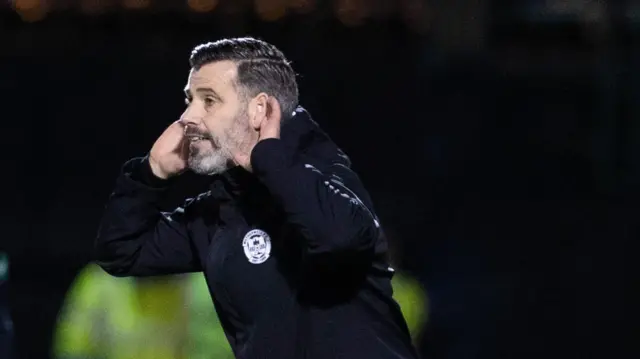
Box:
95, 158, 201, 277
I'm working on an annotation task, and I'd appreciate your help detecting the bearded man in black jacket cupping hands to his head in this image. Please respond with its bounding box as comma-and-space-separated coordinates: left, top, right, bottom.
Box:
96, 38, 416, 359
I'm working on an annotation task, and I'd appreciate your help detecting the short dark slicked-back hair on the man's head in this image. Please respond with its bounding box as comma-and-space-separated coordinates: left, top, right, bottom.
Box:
189, 37, 298, 119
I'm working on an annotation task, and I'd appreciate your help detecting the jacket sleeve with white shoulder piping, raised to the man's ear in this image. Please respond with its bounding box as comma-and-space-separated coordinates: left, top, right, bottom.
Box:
251, 139, 380, 255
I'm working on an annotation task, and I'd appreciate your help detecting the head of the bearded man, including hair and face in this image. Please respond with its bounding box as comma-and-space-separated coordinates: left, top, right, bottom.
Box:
182, 38, 298, 175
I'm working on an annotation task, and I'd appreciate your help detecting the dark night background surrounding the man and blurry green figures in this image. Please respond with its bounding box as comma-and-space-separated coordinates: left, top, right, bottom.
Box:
0, 0, 640, 359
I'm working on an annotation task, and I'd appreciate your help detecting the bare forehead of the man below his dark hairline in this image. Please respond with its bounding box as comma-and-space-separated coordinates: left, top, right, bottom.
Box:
187, 61, 238, 92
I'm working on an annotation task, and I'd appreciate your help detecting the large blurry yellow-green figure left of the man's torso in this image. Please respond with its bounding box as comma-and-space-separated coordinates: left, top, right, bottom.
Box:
53, 264, 233, 359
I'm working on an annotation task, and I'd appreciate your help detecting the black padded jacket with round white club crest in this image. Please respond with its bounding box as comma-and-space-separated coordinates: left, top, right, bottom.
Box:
96, 108, 416, 359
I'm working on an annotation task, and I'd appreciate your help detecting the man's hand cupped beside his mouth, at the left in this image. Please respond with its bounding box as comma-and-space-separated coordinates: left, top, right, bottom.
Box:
149, 121, 189, 179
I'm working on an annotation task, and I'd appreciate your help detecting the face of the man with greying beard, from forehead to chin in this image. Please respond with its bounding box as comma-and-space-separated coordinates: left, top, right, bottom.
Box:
181, 61, 253, 175
